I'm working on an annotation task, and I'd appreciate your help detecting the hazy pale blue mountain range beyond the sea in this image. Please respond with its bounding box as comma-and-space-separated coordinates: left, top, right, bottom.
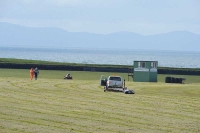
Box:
0, 22, 200, 51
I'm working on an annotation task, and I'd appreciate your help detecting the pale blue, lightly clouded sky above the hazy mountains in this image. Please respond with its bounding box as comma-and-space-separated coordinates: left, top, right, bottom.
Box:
0, 0, 200, 35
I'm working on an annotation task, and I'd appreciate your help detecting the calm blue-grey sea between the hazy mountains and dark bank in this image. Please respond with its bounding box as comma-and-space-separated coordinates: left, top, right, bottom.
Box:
0, 46, 200, 68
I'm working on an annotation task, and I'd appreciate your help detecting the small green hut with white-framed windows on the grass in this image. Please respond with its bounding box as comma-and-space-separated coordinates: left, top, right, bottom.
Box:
133, 61, 158, 82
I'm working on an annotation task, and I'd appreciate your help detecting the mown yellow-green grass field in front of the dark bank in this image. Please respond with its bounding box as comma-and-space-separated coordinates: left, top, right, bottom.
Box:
0, 69, 200, 133
